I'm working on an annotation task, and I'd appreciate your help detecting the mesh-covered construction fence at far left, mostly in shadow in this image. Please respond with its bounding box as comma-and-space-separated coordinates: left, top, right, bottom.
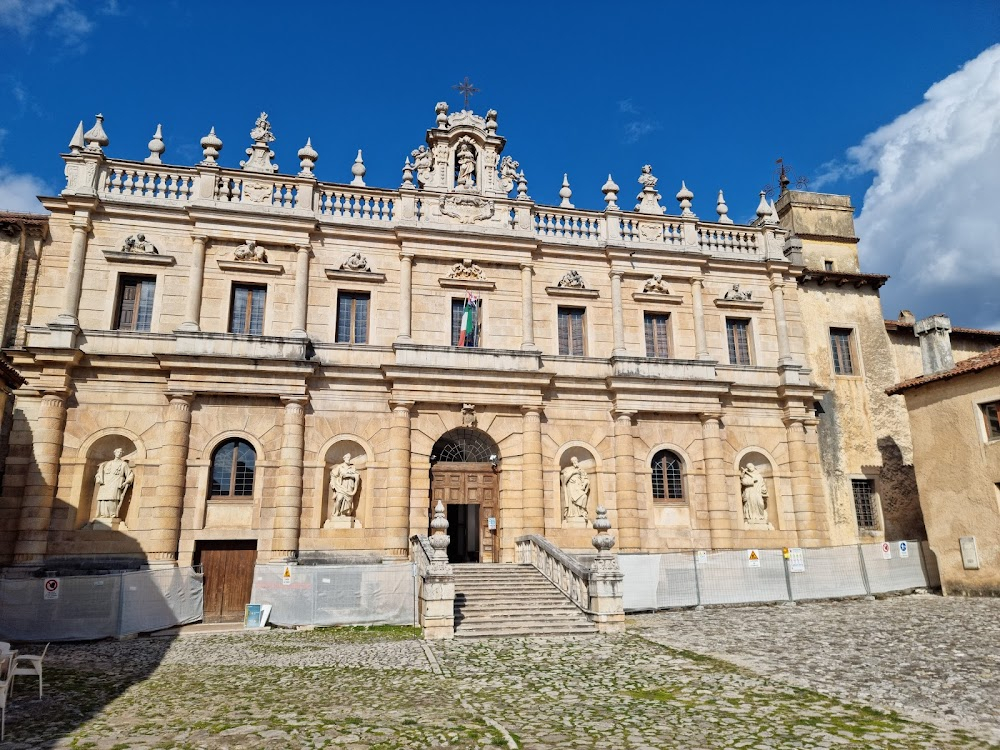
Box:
0, 568, 204, 641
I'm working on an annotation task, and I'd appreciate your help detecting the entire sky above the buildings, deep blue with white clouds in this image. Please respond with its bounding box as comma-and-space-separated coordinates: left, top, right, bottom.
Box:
0, 0, 1000, 327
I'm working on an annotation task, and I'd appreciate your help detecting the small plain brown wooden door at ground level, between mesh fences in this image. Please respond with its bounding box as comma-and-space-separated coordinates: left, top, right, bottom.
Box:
198, 540, 257, 622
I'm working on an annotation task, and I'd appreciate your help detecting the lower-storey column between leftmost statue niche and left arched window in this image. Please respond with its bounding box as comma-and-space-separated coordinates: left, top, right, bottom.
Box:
145, 393, 193, 565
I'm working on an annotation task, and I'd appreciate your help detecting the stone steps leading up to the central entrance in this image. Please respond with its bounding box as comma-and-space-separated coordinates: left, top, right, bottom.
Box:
452, 563, 597, 638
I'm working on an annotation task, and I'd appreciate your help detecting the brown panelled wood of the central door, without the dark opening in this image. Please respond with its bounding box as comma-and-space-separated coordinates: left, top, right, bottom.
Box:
431, 462, 500, 562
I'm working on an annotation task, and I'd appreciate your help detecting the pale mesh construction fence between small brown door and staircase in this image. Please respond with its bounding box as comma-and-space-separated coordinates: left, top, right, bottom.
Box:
250, 563, 417, 627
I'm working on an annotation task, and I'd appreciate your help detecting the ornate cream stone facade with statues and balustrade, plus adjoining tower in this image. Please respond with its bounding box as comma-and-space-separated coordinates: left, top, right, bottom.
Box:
0, 104, 916, 580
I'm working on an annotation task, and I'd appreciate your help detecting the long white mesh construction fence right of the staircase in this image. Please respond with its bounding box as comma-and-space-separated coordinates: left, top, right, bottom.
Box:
618, 541, 937, 611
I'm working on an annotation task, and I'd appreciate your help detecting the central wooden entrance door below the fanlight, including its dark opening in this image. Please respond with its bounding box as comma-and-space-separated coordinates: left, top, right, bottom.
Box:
431, 462, 500, 563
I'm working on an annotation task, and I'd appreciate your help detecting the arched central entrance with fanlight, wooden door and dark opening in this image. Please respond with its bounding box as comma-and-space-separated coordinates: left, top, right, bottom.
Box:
430, 427, 500, 563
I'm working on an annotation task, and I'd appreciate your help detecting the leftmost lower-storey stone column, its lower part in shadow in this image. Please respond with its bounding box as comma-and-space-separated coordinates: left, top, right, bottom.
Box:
14, 393, 68, 564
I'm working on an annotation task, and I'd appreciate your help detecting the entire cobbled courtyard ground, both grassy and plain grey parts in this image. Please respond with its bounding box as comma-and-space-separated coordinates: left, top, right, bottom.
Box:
0, 595, 1000, 750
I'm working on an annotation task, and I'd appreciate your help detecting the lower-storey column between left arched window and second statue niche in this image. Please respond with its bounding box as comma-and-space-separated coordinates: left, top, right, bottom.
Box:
271, 396, 307, 561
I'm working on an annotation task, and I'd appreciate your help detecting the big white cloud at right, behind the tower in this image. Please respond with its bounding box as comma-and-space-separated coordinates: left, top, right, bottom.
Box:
848, 45, 1000, 327
